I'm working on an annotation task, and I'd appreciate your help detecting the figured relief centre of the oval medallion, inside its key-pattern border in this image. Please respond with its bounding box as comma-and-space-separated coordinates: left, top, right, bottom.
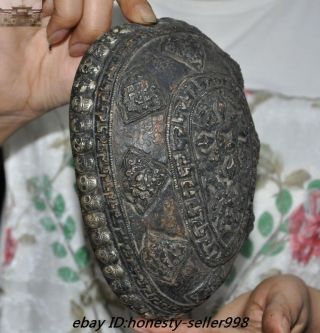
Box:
193, 90, 251, 252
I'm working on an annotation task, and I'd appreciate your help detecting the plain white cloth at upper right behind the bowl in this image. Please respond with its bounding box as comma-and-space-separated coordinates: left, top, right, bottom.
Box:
150, 0, 320, 97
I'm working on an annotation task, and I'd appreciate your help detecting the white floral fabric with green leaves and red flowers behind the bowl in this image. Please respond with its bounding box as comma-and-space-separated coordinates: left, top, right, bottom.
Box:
0, 91, 320, 333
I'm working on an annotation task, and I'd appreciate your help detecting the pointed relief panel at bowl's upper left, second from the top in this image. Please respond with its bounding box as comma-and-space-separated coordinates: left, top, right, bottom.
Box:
120, 68, 165, 124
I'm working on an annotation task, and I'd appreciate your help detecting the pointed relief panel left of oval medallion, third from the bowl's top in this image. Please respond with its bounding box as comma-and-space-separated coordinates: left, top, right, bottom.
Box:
122, 148, 168, 215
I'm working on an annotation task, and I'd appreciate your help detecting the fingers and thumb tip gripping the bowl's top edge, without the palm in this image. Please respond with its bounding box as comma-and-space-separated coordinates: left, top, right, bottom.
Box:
43, 0, 156, 57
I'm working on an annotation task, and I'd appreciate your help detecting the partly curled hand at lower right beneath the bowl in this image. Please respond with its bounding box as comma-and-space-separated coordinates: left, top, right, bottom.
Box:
136, 275, 320, 333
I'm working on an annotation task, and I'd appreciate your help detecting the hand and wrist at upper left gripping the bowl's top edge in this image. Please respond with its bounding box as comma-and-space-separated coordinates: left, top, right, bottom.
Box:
0, 0, 156, 144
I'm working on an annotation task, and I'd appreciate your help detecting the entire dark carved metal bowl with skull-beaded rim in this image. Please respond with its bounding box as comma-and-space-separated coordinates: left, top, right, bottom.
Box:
70, 19, 259, 318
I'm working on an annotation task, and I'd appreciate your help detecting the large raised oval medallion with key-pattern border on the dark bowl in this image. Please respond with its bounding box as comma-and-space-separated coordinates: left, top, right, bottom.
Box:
167, 73, 255, 267
